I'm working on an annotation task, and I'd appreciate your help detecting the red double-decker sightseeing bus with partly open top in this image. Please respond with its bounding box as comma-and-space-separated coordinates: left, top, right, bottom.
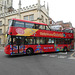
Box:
4, 19, 74, 55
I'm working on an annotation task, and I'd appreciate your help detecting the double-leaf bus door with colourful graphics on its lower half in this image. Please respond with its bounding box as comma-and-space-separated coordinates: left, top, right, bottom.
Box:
12, 36, 24, 54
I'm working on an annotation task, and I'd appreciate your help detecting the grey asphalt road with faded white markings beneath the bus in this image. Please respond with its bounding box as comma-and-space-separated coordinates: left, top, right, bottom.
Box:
0, 50, 75, 75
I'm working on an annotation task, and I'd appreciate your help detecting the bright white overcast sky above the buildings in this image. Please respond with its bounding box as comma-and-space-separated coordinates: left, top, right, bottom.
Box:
13, 0, 75, 28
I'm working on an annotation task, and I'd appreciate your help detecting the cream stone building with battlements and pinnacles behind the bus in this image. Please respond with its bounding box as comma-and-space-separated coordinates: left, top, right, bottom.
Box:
0, 0, 50, 45
